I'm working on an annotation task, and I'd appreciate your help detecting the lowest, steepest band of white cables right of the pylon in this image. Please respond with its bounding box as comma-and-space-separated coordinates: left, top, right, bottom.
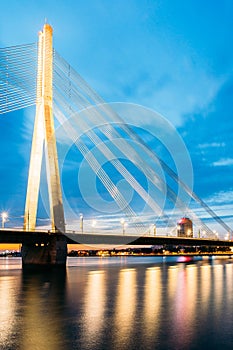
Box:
54, 103, 145, 232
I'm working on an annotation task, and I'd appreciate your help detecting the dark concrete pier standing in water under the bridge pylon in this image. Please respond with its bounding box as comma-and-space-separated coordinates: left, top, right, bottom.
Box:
21, 234, 67, 268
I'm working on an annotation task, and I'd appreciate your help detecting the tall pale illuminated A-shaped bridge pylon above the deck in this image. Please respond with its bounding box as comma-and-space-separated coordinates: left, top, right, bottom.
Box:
24, 24, 65, 233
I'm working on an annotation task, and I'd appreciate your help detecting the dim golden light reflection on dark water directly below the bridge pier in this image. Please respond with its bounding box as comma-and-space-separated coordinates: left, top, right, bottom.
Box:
17, 274, 63, 350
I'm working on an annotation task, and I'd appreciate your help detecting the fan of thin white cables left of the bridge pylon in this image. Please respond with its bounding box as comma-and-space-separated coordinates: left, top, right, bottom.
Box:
0, 43, 37, 114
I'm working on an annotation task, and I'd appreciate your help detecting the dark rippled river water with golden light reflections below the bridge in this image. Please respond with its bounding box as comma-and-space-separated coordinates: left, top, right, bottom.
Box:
0, 257, 233, 350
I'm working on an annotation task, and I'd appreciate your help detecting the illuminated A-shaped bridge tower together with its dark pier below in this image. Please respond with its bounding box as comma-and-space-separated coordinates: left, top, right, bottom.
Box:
22, 24, 67, 265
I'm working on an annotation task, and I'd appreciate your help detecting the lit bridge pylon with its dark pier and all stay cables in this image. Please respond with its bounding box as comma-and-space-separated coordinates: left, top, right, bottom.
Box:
0, 24, 231, 264
